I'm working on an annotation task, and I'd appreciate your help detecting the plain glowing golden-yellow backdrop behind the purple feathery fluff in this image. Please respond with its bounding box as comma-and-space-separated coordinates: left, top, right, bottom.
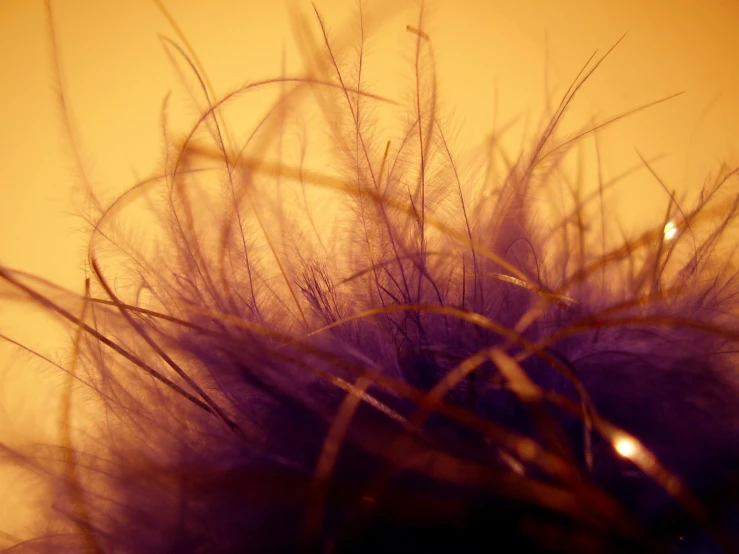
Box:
0, 0, 739, 547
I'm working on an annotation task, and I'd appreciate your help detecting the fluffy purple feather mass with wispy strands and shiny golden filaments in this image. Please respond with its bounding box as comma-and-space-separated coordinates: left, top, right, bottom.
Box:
0, 1, 739, 553
